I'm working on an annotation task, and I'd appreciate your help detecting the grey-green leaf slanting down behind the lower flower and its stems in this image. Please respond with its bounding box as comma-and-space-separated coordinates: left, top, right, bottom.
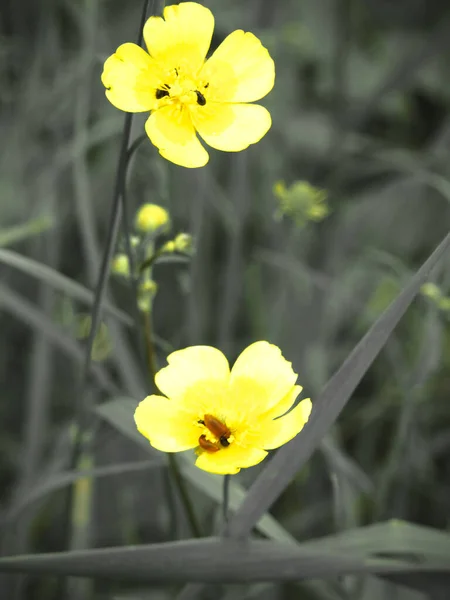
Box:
95, 398, 296, 544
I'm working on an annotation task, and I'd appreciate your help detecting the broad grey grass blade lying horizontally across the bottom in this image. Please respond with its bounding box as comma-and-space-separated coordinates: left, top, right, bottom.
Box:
0, 538, 450, 583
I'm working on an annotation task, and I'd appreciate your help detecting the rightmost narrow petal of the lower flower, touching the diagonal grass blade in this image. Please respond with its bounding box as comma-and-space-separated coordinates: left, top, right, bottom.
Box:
258, 398, 312, 450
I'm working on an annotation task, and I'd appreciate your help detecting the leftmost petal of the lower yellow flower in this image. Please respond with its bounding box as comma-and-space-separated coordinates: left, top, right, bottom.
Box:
134, 396, 199, 452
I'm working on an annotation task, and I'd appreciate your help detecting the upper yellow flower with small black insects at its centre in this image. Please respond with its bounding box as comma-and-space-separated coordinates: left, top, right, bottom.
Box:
102, 2, 275, 167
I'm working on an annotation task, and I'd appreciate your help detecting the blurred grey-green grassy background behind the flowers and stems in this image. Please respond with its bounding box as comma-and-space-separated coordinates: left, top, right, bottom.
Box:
0, 0, 450, 600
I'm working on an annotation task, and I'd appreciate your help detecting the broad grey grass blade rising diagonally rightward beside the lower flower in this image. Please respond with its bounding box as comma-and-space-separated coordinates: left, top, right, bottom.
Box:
225, 234, 450, 537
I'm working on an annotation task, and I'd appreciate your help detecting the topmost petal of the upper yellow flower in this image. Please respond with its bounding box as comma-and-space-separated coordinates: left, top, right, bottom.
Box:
144, 2, 214, 73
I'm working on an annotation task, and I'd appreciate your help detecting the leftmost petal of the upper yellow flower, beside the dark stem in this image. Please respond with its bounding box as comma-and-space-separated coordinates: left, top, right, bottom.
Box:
102, 44, 161, 112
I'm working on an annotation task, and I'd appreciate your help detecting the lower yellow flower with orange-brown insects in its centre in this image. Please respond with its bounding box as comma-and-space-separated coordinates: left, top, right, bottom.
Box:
134, 342, 311, 474
